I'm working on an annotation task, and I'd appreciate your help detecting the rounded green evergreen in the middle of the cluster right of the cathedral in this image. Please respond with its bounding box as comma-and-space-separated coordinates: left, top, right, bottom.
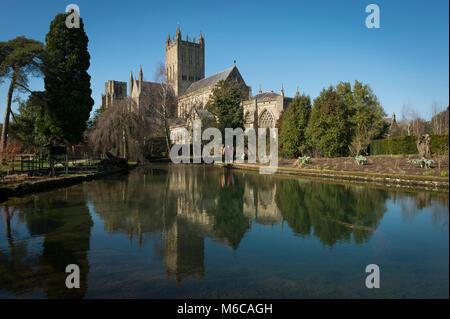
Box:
306, 85, 351, 157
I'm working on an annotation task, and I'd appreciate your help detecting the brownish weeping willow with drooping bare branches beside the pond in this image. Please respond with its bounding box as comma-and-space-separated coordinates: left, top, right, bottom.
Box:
88, 98, 153, 161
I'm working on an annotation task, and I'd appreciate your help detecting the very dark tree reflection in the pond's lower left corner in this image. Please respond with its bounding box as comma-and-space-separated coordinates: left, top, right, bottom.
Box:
0, 188, 92, 298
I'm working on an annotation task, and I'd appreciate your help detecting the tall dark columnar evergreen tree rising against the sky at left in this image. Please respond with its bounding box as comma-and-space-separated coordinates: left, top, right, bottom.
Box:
43, 14, 94, 143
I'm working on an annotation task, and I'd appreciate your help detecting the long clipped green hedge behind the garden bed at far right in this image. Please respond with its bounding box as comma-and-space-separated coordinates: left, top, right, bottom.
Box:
369, 135, 448, 155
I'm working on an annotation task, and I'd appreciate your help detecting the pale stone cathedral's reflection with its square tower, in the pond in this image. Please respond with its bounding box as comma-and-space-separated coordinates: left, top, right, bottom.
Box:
164, 167, 283, 285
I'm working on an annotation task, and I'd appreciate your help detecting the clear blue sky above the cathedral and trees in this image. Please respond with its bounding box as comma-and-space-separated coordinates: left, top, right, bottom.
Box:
0, 0, 449, 119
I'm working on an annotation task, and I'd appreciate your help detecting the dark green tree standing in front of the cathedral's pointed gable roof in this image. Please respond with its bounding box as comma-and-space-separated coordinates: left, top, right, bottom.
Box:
206, 80, 246, 136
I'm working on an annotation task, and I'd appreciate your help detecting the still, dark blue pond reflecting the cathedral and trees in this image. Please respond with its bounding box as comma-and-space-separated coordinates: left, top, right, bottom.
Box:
0, 164, 449, 298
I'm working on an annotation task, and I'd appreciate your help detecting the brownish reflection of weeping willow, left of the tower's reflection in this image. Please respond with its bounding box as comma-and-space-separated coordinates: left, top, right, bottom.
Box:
85, 170, 175, 245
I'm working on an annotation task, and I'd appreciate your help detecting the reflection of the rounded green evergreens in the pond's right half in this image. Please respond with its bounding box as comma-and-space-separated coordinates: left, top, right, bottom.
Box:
277, 179, 388, 247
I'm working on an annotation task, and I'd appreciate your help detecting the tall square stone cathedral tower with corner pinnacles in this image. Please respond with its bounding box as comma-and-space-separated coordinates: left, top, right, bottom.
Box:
166, 27, 205, 96
